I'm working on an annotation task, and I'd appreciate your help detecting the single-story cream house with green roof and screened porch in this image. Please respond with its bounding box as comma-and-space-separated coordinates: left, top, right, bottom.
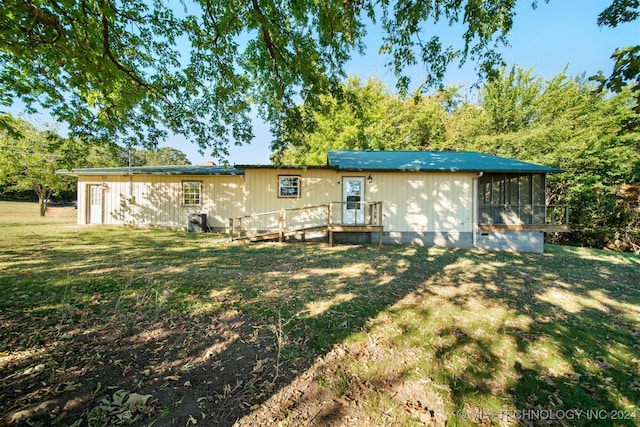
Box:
61, 150, 568, 252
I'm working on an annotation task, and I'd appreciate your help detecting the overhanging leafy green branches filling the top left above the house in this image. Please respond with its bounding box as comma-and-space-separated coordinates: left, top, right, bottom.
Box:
0, 0, 535, 160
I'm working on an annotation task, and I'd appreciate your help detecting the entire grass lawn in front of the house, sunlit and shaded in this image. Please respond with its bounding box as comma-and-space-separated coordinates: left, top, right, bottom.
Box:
0, 202, 640, 426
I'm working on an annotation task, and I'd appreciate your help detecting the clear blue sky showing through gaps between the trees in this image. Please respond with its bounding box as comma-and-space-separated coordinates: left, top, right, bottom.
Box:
14, 0, 640, 164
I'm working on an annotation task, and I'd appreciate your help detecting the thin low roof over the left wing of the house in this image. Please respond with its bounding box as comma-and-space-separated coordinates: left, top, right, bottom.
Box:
58, 165, 244, 176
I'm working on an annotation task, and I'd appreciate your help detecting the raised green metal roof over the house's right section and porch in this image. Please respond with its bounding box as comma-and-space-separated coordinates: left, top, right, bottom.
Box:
327, 150, 562, 173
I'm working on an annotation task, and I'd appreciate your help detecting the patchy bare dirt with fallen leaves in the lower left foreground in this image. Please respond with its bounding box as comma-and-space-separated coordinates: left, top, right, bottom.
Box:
0, 310, 412, 426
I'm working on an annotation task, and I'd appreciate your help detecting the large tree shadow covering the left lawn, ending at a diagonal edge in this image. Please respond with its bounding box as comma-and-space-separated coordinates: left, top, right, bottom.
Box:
0, 231, 459, 425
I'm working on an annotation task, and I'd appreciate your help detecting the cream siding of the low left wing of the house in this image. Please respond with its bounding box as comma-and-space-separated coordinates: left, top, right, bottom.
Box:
78, 175, 243, 230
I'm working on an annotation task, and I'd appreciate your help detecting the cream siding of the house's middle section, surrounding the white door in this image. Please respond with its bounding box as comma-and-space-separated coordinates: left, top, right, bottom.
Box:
244, 168, 475, 246
